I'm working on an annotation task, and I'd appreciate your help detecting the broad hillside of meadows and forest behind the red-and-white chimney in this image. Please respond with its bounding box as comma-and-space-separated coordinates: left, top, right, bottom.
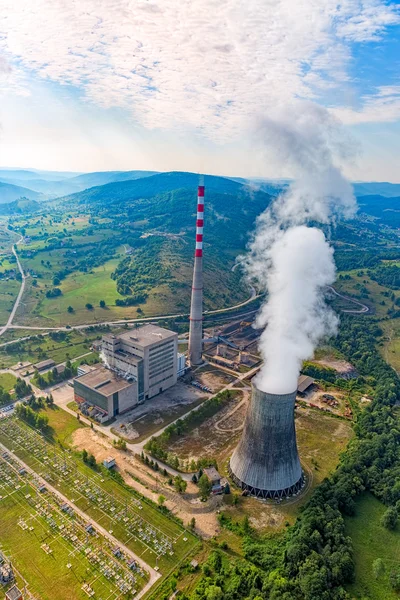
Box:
3, 173, 271, 324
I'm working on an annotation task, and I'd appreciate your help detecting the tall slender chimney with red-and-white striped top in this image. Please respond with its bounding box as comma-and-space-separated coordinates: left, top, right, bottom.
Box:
189, 175, 204, 367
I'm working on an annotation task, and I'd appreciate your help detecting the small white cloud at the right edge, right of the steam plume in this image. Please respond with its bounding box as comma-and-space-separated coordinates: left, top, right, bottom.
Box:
331, 86, 400, 125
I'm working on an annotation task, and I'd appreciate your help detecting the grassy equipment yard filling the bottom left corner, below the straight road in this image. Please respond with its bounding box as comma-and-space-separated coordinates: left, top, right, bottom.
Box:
0, 452, 148, 600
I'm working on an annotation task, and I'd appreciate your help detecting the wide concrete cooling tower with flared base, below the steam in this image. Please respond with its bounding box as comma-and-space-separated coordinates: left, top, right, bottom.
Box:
229, 383, 304, 498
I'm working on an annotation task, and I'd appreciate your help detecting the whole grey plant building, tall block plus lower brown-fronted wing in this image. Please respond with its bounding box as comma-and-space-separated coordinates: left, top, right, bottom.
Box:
74, 325, 180, 423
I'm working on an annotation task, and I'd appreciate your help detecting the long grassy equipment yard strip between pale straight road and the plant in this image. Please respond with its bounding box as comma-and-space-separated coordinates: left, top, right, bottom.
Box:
0, 417, 198, 574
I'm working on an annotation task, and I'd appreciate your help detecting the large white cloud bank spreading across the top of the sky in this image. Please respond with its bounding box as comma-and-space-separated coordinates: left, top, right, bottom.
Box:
0, 0, 398, 140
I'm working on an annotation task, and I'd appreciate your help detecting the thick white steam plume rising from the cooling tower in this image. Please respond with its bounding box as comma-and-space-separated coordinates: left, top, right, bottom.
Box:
243, 102, 356, 394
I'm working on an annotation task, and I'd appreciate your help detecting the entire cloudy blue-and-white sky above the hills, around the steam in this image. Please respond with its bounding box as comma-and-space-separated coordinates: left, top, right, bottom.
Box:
0, 0, 400, 182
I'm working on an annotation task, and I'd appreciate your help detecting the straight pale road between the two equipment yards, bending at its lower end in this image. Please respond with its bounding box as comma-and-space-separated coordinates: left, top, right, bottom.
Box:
0, 443, 161, 600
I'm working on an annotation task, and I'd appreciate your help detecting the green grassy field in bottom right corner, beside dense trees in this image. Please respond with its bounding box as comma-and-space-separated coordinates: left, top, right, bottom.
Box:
346, 494, 400, 600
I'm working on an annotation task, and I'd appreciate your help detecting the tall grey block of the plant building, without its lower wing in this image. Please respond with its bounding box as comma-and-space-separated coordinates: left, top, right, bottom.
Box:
102, 325, 178, 402
